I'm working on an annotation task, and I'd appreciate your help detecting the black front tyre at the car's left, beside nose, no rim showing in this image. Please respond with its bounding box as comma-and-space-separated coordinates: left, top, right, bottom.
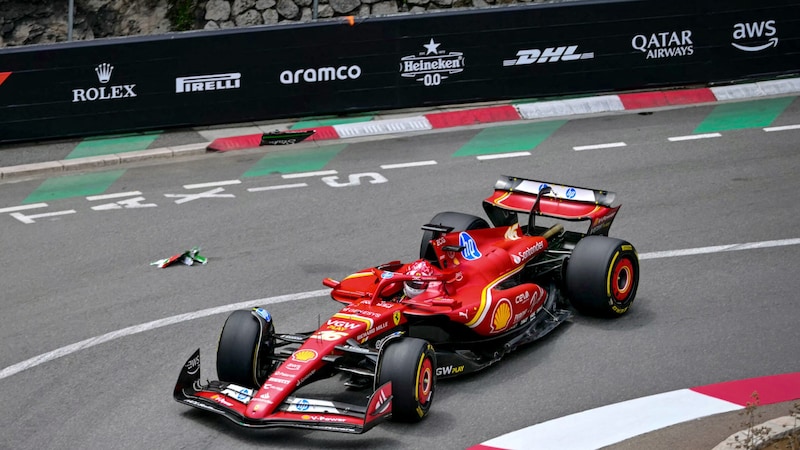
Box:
217, 310, 274, 387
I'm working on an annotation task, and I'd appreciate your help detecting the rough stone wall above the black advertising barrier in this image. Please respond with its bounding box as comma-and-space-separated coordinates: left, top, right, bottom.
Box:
0, 0, 558, 47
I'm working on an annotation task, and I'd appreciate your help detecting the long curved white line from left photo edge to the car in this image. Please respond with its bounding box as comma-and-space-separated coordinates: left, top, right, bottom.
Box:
0, 289, 331, 380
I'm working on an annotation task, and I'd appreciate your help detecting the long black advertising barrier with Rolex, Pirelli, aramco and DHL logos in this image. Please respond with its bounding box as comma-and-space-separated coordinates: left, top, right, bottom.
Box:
0, 0, 800, 142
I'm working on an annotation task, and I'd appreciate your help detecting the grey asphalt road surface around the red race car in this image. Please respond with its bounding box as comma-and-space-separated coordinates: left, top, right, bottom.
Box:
0, 101, 800, 449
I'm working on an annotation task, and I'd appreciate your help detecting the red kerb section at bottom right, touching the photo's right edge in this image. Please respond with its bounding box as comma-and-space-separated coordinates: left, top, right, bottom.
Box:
691, 372, 800, 406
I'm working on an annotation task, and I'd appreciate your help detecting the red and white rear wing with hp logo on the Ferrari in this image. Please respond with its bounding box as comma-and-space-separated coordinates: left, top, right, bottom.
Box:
483, 175, 621, 235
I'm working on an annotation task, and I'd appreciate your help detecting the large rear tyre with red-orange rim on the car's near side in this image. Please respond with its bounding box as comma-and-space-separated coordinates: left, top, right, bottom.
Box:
564, 236, 639, 317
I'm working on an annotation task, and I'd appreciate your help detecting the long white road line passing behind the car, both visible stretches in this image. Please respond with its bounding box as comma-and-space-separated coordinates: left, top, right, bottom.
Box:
0, 238, 800, 380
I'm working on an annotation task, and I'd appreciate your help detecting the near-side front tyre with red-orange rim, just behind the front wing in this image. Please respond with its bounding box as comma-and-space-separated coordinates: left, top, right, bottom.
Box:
377, 338, 436, 422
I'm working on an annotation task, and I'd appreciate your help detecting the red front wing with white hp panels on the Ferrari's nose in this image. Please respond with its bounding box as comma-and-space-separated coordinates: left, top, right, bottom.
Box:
173, 349, 392, 434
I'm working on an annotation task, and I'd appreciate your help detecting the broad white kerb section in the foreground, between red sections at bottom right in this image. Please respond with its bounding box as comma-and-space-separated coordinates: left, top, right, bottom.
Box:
483, 389, 743, 450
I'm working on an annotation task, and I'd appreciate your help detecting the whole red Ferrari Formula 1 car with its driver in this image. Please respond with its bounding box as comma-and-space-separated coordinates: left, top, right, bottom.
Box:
174, 177, 639, 433
